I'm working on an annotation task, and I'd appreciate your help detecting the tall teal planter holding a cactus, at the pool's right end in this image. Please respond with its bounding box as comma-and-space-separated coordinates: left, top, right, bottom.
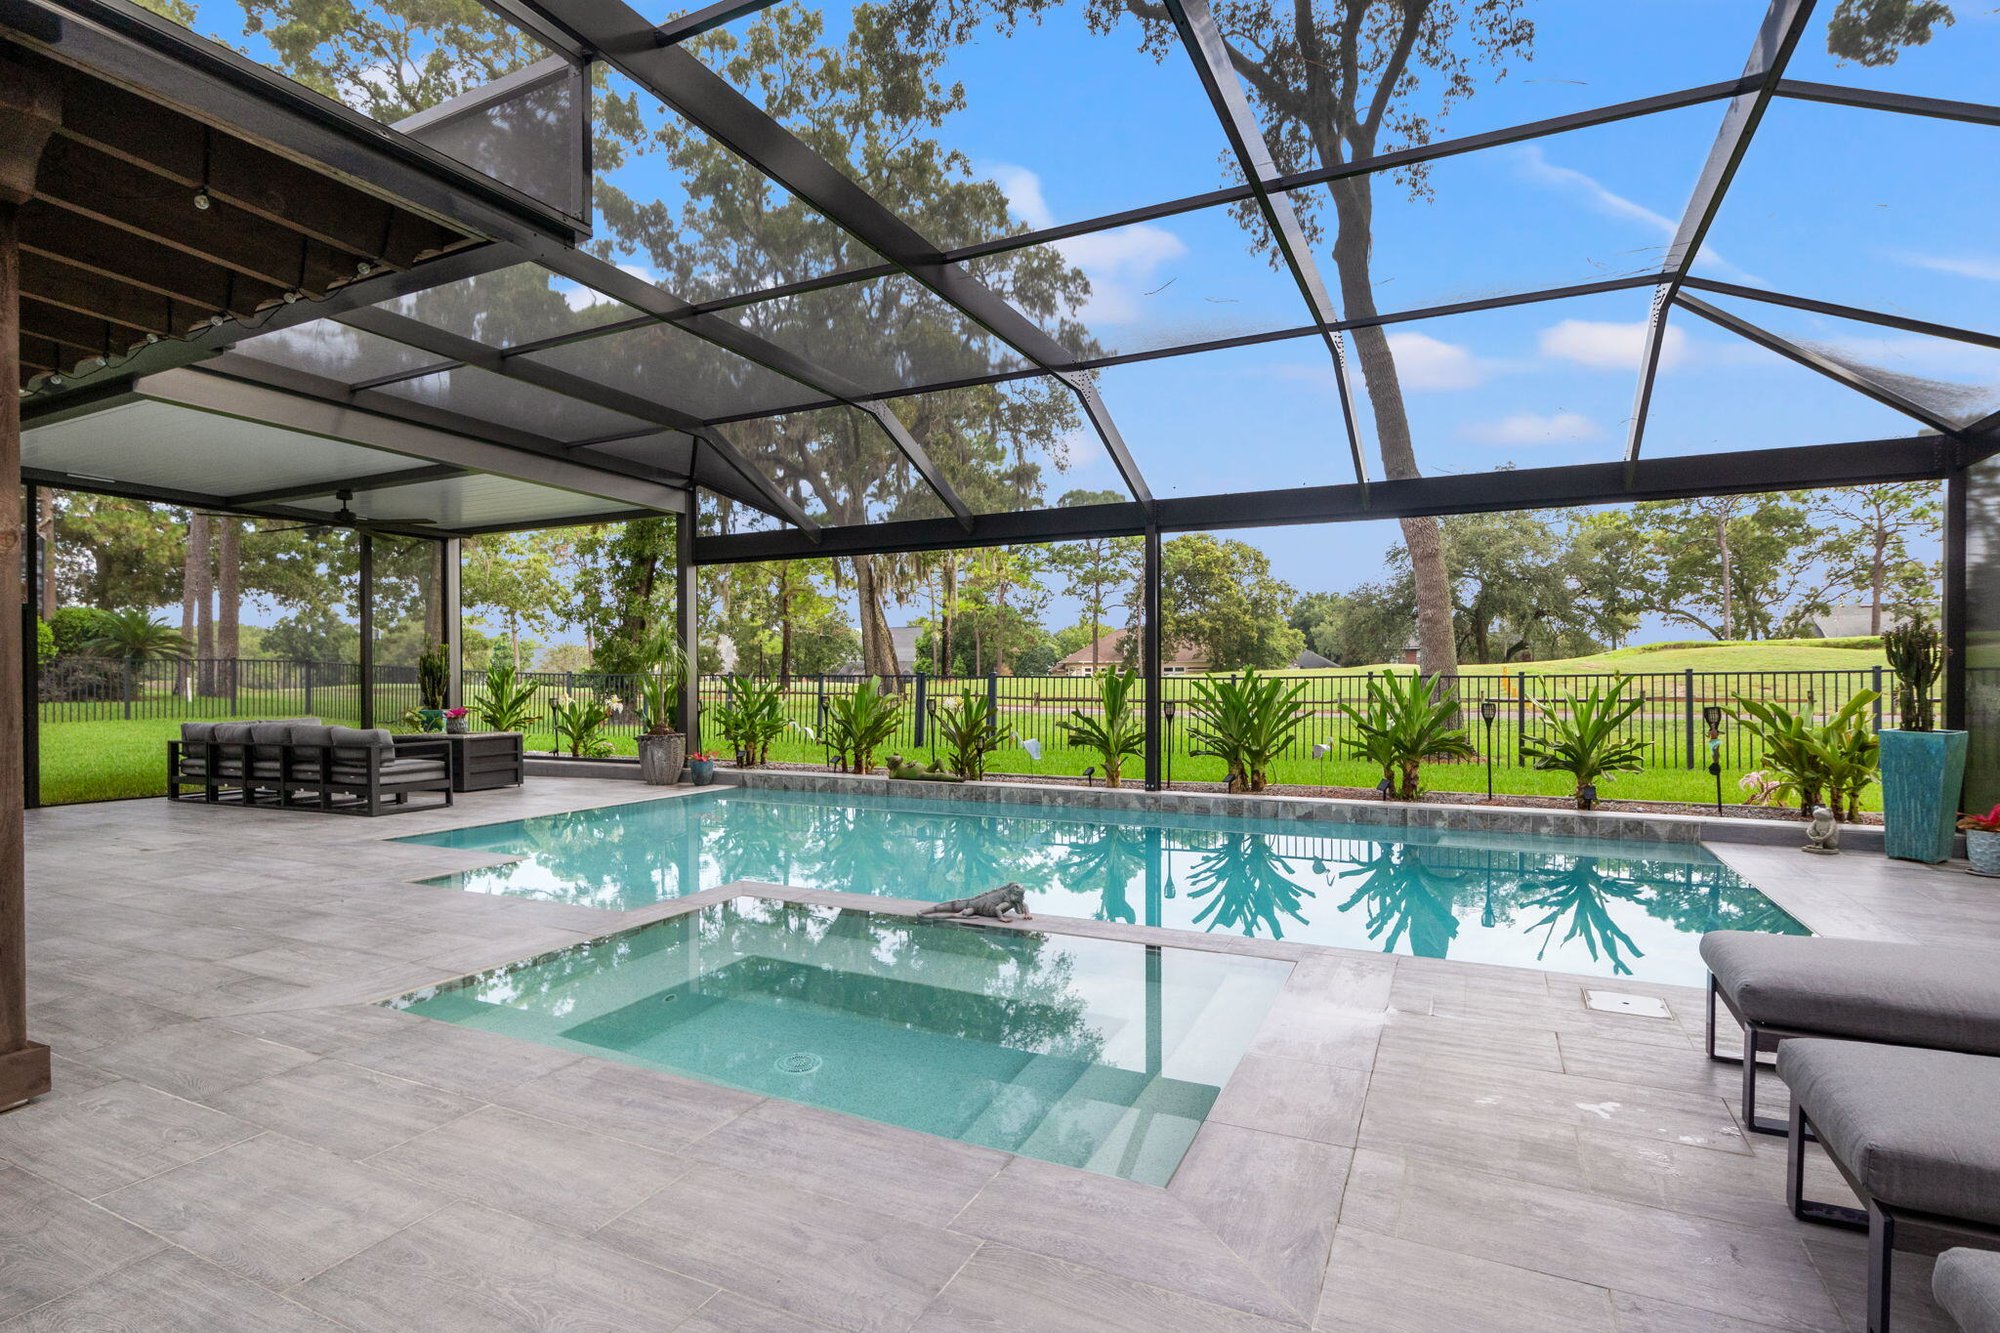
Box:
1880, 616, 1966, 863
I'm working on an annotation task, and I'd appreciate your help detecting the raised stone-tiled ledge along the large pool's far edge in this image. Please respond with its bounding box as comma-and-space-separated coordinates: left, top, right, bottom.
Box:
718, 769, 1882, 853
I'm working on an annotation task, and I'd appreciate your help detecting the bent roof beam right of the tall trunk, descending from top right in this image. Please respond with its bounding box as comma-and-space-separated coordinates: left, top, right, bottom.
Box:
1626, 0, 1812, 462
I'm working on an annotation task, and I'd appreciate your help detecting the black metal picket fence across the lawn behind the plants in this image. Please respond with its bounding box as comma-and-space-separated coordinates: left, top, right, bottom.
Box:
42, 658, 1920, 773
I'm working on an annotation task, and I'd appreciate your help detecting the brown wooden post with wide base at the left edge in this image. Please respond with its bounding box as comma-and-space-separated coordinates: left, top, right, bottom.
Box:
0, 60, 62, 1111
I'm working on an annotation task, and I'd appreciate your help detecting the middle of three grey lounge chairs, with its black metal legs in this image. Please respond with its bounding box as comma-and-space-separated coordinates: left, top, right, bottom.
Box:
1778, 1037, 2000, 1333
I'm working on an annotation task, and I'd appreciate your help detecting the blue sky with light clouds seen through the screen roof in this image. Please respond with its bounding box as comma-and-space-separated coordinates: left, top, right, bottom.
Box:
172, 0, 2000, 636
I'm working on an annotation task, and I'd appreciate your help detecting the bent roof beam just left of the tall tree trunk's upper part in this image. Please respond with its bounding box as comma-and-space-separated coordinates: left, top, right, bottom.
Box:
1162, 0, 1368, 486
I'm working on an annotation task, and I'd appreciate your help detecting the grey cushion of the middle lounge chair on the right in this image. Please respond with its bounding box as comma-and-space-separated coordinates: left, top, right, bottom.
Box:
1778, 1037, 2000, 1225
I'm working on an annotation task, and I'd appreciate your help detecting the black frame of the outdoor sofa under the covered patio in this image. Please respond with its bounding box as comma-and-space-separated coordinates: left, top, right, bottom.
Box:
166, 741, 456, 815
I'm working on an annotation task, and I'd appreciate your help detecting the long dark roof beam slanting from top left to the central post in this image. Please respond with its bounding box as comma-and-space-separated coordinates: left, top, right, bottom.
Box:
516, 0, 1152, 502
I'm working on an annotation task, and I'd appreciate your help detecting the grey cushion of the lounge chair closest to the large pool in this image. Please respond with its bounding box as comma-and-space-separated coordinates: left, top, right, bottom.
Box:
1702, 931, 2000, 1055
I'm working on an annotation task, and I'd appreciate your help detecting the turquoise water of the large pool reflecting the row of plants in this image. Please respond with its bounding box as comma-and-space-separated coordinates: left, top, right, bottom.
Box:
402, 789, 1806, 985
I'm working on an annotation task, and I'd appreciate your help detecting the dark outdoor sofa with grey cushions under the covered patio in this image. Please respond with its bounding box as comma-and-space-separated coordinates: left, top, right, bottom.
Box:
166, 717, 452, 815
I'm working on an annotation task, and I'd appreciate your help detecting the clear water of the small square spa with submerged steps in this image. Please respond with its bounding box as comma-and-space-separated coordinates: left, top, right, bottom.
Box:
392, 897, 1292, 1185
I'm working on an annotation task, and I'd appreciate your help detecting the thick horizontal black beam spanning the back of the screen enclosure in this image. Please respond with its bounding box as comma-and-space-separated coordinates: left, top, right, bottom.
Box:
696, 434, 1958, 564
